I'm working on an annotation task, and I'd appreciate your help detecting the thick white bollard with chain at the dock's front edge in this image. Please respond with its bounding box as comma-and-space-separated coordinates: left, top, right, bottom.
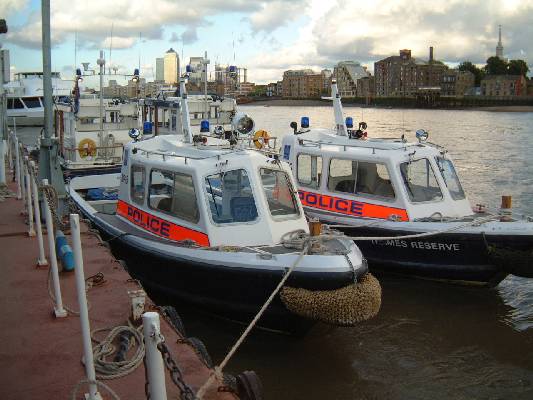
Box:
143, 312, 167, 400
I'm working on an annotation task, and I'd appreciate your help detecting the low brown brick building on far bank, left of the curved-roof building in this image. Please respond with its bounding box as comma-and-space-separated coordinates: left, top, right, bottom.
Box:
282, 69, 324, 99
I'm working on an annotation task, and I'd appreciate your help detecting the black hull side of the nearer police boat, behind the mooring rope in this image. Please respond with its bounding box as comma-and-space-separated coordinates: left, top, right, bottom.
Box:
88, 215, 354, 335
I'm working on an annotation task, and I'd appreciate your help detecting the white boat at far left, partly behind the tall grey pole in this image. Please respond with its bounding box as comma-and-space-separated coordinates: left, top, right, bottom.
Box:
4, 72, 72, 126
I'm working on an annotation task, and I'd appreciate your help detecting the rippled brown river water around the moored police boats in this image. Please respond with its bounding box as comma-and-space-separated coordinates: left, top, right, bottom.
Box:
14, 106, 533, 400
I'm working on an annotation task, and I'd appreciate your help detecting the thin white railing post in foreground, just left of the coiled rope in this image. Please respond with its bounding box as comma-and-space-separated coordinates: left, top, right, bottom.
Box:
70, 214, 102, 400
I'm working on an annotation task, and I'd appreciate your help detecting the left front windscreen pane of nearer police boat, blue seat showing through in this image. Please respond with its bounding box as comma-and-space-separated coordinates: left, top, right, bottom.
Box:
205, 169, 257, 224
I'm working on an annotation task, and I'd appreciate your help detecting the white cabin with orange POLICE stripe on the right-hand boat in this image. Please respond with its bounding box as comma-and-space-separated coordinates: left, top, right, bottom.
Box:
281, 129, 473, 221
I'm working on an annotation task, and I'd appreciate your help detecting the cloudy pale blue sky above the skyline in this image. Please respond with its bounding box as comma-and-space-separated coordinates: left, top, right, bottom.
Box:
0, 0, 533, 83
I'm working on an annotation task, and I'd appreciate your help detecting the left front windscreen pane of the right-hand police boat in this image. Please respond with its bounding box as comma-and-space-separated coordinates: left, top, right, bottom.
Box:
400, 158, 442, 203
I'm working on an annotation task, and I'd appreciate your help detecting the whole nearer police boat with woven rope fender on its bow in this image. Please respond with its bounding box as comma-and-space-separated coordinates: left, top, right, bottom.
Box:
68, 82, 381, 332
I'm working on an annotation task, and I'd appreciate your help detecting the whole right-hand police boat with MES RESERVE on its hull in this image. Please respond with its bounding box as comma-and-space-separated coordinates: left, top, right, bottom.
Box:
280, 82, 533, 286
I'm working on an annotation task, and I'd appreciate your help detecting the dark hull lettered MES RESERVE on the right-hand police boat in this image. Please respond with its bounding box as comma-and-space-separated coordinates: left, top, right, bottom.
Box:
340, 227, 533, 286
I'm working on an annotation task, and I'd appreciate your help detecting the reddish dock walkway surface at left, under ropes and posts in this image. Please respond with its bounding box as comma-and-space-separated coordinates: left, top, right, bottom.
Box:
0, 184, 236, 400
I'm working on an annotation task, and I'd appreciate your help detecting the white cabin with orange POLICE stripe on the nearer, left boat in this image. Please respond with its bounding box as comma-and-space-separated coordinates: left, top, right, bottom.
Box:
117, 136, 308, 246
